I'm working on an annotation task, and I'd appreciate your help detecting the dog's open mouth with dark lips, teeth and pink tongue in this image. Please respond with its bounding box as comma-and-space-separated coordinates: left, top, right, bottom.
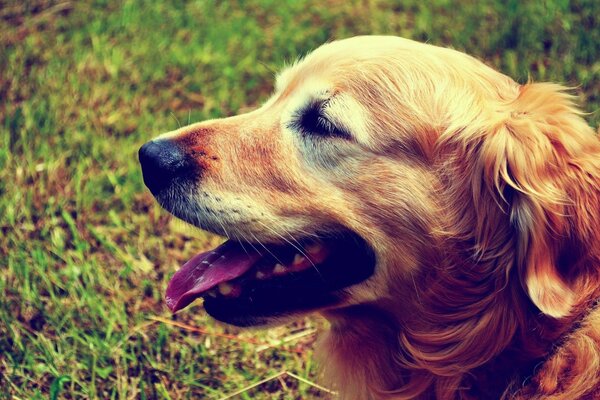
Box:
166, 233, 375, 326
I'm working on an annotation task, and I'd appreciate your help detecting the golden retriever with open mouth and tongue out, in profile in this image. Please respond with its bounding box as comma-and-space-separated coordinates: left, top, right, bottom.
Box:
139, 36, 600, 400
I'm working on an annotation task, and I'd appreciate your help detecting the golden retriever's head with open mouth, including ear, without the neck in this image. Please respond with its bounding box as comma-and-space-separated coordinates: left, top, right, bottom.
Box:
139, 37, 598, 325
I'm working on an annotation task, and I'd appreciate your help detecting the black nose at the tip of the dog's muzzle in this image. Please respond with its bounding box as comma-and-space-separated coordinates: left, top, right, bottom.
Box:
138, 140, 193, 195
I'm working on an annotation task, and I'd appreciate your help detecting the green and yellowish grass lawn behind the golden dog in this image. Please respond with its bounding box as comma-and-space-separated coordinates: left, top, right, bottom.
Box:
0, 0, 600, 399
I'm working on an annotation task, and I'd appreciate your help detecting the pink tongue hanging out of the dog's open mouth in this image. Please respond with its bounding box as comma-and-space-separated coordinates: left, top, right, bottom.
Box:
165, 240, 262, 312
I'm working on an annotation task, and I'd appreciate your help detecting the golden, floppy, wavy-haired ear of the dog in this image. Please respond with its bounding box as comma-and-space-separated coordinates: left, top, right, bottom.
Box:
472, 83, 593, 318
